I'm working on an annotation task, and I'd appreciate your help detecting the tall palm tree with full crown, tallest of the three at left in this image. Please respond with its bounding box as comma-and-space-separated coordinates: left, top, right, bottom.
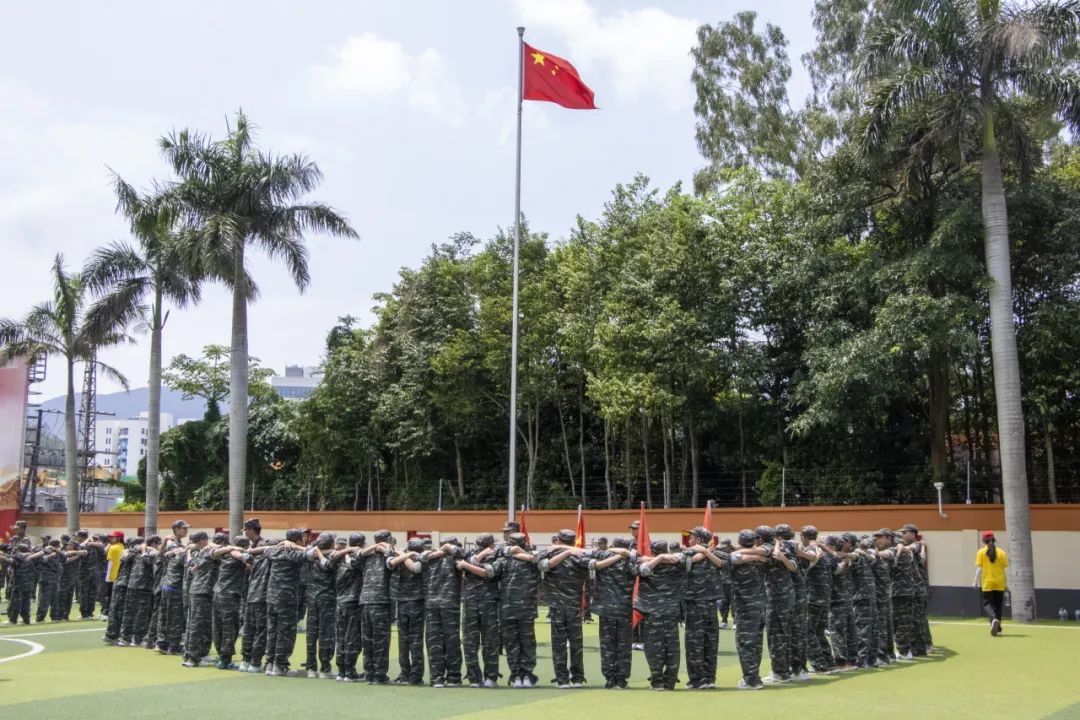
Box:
161, 111, 356, 534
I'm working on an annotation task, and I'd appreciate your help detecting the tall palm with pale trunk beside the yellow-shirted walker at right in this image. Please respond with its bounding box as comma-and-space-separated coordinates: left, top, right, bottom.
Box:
859, 0, 1080, 622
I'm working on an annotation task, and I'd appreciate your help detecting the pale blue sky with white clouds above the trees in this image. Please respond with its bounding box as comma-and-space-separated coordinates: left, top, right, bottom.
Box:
0, 0, 814, 397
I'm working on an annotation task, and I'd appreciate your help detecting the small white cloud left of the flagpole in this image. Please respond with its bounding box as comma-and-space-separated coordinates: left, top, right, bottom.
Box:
312, 32, 465, 126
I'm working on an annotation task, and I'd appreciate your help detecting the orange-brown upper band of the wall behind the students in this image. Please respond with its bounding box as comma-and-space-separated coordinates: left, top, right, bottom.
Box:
22, 505, 1080, 534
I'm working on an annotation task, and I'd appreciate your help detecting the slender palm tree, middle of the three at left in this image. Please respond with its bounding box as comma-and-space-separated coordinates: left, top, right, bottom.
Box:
83, 177, 200, 535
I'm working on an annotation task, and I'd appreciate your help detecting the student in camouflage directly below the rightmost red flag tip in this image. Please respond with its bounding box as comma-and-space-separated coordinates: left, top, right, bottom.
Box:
683, 527, 728, 690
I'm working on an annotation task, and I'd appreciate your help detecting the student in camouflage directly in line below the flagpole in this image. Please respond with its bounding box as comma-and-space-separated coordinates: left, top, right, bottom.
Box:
485, 532, 540, 689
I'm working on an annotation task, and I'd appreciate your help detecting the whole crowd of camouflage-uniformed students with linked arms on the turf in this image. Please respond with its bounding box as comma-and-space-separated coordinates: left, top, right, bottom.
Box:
0, 518, 946, 690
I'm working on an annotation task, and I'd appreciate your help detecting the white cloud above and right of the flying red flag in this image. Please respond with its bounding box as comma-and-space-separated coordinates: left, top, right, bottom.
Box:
516, 0, 701, 110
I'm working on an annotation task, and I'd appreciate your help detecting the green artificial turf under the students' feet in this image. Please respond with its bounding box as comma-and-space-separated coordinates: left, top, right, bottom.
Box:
0, 619, 1080, 720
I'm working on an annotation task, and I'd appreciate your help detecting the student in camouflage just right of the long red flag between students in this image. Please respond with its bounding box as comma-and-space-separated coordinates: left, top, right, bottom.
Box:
634, 540, 690, 690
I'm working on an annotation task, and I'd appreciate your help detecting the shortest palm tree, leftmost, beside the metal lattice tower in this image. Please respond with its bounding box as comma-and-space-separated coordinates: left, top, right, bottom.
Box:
0, 255, 129, 534
